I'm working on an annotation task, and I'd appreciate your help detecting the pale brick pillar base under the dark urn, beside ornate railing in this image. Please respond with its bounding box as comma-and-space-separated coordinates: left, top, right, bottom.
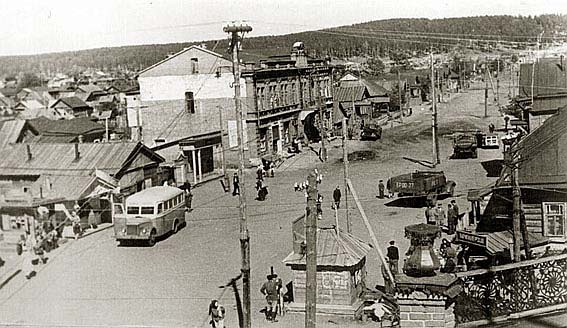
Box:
396, 291, 455, 328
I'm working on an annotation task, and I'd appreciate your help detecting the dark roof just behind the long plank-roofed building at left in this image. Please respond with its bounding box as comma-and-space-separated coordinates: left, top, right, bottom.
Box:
28, 117, 105, 136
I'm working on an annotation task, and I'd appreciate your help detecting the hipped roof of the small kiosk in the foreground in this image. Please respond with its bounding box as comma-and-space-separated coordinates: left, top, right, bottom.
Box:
283, 228, 371, 267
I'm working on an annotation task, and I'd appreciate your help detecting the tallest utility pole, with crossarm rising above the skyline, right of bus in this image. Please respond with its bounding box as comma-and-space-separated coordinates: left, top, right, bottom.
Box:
223, 23, 252, 328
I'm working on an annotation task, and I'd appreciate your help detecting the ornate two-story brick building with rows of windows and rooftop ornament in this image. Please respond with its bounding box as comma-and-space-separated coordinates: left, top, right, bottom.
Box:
242, 42, 333, 158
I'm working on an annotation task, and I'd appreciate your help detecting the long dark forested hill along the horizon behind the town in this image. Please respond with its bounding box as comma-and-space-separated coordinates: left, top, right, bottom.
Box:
0, 15, 567, 76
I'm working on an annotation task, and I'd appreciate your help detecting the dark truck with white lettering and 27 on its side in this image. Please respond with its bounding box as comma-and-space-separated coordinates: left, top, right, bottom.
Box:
387, 171, 456, 199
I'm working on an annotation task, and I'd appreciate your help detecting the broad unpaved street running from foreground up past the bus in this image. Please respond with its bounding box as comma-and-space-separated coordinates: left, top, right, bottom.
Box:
0, 85, 501, 327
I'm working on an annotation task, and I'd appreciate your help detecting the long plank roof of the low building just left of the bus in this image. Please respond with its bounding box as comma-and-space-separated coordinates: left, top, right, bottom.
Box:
0, 142, 164, 175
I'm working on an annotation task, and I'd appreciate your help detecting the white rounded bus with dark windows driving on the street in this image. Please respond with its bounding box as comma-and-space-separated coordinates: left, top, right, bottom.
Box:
113, 186, 185, 246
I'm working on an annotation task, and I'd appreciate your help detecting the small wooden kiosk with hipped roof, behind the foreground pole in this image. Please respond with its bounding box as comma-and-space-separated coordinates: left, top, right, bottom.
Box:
283, 217, 371, 316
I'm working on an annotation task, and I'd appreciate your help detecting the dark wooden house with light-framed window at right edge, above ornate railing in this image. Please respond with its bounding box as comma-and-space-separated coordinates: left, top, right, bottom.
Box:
457, 108, 567, 260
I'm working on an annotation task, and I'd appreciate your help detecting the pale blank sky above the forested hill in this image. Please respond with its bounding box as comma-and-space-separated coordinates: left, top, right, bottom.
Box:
0, 0, 567, 56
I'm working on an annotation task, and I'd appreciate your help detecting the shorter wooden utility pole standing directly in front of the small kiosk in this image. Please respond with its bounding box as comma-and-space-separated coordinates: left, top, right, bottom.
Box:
305, 172, 318, 328
